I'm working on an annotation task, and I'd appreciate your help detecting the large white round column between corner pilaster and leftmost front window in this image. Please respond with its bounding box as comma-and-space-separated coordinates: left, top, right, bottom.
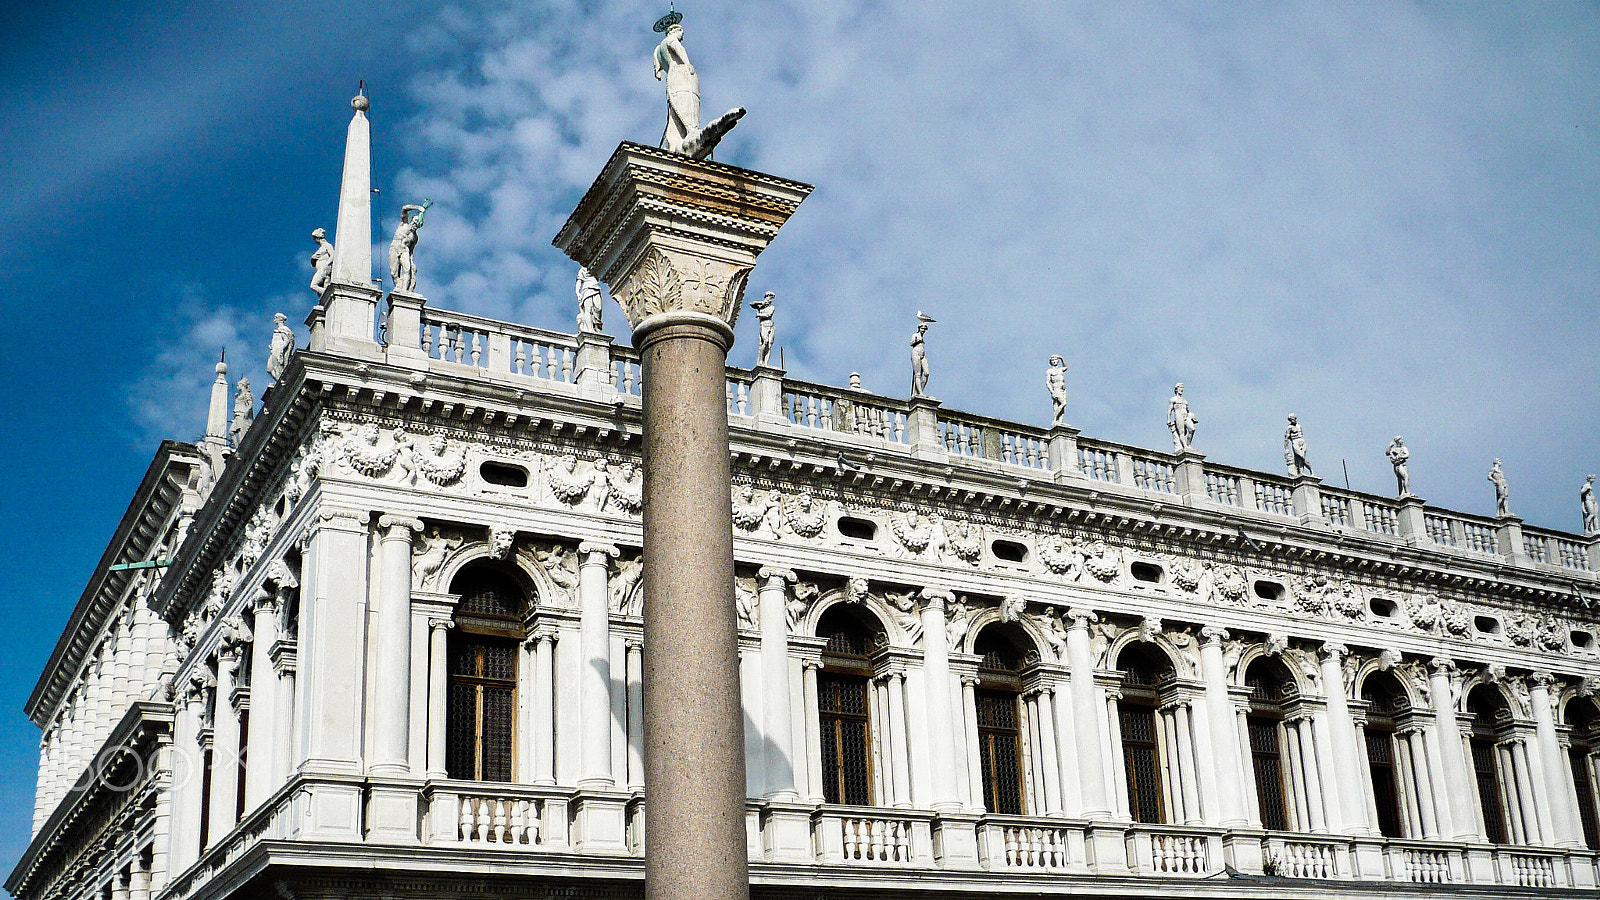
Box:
368, 516, 422, 777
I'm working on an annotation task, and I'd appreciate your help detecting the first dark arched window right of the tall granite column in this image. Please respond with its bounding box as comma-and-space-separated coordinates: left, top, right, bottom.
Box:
816, 605, 883, 806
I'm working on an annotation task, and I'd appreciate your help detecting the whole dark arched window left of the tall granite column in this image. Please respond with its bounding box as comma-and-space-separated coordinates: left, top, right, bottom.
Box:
445, 569, 526, 781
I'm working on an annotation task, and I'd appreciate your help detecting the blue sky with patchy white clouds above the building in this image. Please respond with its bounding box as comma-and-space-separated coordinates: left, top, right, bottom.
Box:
0, 0, 1600, 868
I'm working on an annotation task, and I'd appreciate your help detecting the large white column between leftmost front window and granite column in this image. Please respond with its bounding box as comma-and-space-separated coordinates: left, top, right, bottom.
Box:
578, 541, 618, 788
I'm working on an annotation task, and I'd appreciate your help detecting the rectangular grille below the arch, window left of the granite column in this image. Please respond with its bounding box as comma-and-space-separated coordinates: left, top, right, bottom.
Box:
445, 633, 517, 781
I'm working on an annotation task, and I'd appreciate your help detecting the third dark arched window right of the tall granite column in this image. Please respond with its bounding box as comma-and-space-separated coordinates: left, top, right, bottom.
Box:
1117, 644, 1173, 823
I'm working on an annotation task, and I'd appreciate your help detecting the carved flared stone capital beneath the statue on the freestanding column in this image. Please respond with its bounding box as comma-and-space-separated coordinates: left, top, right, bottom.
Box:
554, 141, 811, 340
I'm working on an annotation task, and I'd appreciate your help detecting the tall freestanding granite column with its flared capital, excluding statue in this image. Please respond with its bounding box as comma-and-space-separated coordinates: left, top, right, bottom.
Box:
555, 143, 811, 900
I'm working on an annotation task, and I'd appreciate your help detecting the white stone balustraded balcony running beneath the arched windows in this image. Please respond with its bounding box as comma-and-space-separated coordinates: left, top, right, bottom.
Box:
163, 777, 1597, 900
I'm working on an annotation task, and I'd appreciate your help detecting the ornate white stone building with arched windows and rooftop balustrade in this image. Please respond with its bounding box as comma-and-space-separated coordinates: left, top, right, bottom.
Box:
6, 98, 1600, 900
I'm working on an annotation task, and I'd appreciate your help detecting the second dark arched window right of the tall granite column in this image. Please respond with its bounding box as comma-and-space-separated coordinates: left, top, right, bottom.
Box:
973, 625, 1024, 815
